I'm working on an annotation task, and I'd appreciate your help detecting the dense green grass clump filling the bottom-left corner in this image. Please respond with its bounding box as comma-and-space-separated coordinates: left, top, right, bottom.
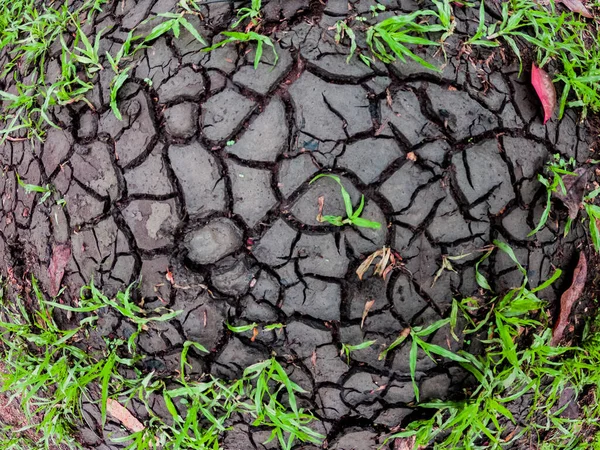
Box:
0, 278, 141, 448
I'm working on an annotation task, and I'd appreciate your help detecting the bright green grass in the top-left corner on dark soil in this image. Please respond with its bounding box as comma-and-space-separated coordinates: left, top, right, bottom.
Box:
0, 0, 206, 143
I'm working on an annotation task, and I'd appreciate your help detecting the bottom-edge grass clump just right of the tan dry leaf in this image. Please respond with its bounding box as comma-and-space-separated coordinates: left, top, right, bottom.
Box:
129, 354, 324, 450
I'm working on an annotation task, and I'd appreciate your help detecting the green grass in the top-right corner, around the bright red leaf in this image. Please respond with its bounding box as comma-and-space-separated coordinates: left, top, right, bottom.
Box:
335, 0, 600, 119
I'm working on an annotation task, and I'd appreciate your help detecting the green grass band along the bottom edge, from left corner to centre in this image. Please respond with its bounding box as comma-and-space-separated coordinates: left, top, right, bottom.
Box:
0, 278, 324, 450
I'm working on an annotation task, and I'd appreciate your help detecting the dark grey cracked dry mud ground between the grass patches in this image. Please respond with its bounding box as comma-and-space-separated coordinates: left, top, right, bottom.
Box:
0, 0, 590, 450
